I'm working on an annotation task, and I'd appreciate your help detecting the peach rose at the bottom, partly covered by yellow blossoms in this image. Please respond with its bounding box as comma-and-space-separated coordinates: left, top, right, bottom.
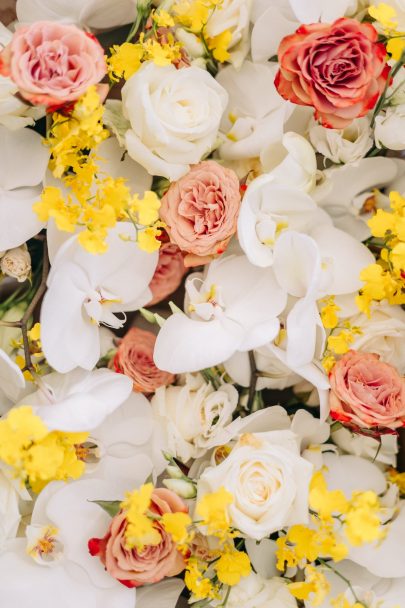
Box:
88, 488, 188, 588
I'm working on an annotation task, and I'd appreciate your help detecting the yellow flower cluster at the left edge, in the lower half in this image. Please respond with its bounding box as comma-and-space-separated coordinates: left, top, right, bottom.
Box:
0, 405, 88, 492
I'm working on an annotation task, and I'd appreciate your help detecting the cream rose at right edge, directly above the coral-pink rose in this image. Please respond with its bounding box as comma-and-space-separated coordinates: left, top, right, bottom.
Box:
348, 305, 405, 374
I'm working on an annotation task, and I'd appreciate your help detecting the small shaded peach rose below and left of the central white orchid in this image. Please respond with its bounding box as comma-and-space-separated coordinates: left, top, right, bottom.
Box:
112, 327, 175, 394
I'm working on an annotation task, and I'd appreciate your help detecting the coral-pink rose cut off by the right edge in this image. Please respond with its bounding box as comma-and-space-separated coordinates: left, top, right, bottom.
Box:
330, 350, 405, 433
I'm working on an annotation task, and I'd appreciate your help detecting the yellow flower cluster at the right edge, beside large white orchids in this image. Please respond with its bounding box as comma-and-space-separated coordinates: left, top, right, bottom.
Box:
356, 192, 405, 316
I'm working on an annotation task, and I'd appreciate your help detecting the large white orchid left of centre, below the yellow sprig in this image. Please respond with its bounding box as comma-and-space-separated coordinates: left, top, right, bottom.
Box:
41, 223, 158, 373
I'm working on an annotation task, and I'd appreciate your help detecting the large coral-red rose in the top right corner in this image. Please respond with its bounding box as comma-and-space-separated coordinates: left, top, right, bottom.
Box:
275, 18, 390, 129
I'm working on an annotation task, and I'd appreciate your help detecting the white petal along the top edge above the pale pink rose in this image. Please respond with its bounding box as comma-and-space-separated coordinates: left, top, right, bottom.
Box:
17, 0, 136, 30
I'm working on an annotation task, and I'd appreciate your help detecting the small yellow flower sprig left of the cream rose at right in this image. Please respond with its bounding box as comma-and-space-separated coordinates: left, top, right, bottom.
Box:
320, 296, 362, 373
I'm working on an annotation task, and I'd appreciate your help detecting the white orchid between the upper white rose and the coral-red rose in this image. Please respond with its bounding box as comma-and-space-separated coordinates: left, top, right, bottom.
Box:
217, 61, 293, 160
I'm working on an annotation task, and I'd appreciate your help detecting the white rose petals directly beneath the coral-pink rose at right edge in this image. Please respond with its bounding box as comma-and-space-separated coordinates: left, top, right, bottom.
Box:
332, 427, 398, 467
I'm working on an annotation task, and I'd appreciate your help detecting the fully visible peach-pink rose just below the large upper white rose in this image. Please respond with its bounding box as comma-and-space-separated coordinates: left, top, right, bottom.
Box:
160, 160, 241, 266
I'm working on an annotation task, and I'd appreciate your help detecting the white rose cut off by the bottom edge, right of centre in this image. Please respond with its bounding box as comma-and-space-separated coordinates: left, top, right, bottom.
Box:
212, 572, 297, 608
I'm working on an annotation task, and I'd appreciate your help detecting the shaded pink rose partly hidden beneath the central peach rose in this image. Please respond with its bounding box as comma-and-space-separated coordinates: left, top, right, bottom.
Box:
148, 243, 187, 306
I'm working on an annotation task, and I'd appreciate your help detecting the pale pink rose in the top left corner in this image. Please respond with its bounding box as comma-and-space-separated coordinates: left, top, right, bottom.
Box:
0, 21, 106, 108
